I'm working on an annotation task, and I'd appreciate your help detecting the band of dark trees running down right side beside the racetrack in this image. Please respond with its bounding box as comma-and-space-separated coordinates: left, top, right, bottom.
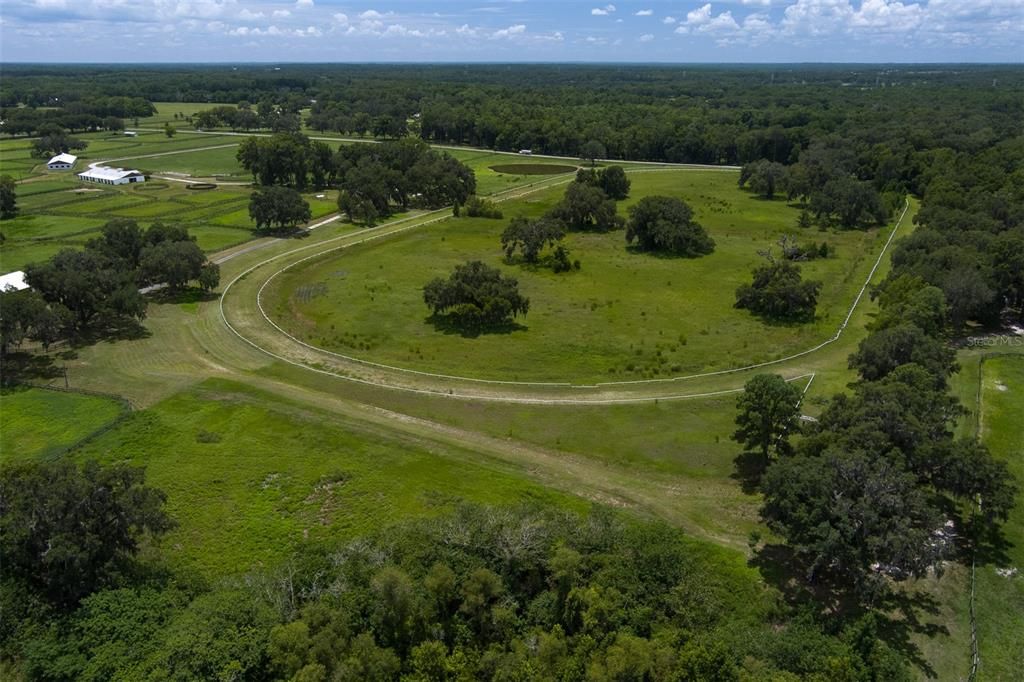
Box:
734, 131, 1024, 603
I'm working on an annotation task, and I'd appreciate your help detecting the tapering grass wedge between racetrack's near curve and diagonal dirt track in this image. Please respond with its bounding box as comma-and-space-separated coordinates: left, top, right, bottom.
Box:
259, 364, 761, 550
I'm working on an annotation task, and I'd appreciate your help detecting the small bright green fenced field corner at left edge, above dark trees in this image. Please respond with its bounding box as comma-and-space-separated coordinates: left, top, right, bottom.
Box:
0, 388, 126, 462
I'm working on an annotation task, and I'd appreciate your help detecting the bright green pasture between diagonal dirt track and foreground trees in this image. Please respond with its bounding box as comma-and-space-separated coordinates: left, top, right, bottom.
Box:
75, 380, 577, 577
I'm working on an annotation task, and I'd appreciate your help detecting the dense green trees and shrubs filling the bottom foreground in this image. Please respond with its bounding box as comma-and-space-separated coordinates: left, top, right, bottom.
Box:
0, 461, 910, 682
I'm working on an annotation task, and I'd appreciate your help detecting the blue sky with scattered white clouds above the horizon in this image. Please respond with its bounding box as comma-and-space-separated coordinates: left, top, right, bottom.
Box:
0, 0, 1024, 62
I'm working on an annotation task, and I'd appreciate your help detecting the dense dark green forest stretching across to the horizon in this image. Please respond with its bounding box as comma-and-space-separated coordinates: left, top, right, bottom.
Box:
0, 65, 1024, 165
